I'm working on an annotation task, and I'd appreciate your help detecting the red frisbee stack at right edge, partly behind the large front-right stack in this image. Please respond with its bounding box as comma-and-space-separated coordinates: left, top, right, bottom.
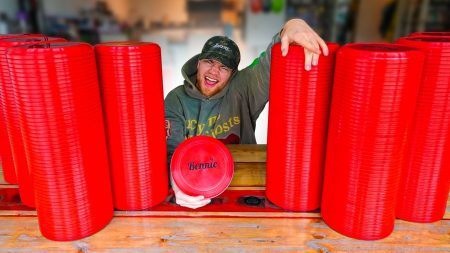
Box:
397, 36, 450, 222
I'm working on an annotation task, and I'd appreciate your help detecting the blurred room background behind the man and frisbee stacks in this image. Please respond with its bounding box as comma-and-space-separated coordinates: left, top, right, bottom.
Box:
0, 0, 450, 143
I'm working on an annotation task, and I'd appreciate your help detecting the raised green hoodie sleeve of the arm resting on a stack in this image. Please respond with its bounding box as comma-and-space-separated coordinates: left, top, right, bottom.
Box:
234, 33, 280, 120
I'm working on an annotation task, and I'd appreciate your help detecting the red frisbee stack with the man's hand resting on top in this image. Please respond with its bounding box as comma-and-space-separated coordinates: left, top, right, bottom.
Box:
266, 43, 339, 211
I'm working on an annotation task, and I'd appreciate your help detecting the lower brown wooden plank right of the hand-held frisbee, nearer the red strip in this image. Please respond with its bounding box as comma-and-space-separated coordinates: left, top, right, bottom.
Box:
230, 162, 266, 187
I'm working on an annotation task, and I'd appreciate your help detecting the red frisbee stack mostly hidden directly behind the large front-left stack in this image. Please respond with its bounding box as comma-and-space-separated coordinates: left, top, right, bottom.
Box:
0, 35, 66, 207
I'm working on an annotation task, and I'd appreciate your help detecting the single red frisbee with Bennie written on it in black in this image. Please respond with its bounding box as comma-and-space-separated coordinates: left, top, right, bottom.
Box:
170, 136, 234, 198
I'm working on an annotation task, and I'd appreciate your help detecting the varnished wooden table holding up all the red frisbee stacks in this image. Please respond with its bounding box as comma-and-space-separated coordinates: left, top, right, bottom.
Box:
0, 145, 450, 253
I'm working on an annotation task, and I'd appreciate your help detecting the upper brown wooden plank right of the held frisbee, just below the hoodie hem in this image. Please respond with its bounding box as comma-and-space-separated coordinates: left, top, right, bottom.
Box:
227, 144, 266, 163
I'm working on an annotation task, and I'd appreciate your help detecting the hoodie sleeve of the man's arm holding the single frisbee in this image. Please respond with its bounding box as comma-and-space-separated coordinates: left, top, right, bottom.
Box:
164, 90, 186, 168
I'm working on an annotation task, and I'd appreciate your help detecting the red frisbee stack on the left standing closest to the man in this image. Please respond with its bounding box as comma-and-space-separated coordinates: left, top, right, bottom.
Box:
95, 42, 169, 210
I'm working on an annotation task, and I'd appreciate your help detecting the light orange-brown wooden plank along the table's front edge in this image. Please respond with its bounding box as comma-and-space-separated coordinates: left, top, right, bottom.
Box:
0, 217, 450, 253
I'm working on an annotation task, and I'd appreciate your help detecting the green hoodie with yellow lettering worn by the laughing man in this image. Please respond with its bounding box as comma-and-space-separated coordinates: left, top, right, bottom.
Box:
164, 34, 280, 161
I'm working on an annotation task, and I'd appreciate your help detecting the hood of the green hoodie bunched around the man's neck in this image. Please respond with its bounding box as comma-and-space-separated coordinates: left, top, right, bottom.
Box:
181, 54, 237, 99
